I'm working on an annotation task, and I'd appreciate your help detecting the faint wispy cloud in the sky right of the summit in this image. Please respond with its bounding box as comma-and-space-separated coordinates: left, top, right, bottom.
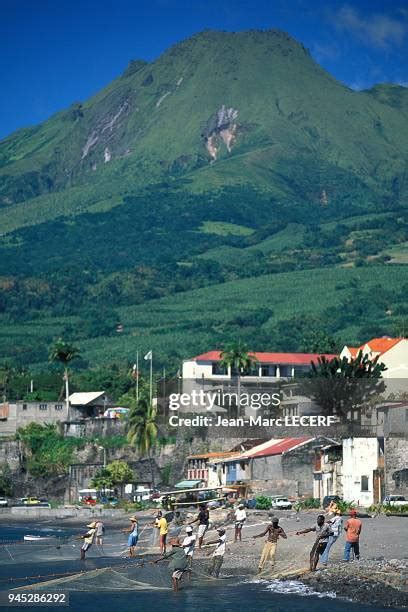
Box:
335, 5, 408, 49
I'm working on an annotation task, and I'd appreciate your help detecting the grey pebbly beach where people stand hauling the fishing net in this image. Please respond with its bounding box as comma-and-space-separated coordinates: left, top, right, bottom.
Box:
0, 510, 408, 609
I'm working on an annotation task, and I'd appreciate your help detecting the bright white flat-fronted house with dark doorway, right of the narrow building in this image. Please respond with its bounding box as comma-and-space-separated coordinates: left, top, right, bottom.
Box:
342, 437, 385, 507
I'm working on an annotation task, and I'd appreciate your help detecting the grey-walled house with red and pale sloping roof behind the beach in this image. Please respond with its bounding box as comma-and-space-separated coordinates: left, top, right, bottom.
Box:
215, 436, 336, 497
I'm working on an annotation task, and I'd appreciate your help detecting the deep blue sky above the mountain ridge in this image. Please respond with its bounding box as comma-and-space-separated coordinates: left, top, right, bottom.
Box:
0, 0, 408, 138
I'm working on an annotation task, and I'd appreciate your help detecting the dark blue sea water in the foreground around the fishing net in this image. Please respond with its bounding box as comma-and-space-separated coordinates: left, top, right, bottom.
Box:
0, 525, 386, 612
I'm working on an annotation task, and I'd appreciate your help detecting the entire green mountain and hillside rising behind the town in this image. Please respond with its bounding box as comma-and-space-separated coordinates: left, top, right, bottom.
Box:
0, 30, 408, 363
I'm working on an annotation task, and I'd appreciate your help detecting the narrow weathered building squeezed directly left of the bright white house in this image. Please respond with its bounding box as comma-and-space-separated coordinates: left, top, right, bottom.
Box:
313, 442, 343, 502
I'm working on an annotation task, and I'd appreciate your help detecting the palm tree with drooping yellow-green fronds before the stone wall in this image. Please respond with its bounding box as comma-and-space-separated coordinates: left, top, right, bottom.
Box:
127, 391, 157, 487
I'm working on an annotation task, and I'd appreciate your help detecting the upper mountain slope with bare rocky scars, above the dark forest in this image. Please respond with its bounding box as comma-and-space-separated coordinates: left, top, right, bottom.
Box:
0, 31, 408, 229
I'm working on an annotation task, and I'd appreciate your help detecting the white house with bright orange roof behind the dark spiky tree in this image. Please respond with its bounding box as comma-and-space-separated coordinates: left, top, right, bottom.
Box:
340, 338, 408, 379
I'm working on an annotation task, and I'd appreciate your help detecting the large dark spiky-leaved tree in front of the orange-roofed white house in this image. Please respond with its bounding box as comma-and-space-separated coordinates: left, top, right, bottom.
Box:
300, 351, 387, 422
